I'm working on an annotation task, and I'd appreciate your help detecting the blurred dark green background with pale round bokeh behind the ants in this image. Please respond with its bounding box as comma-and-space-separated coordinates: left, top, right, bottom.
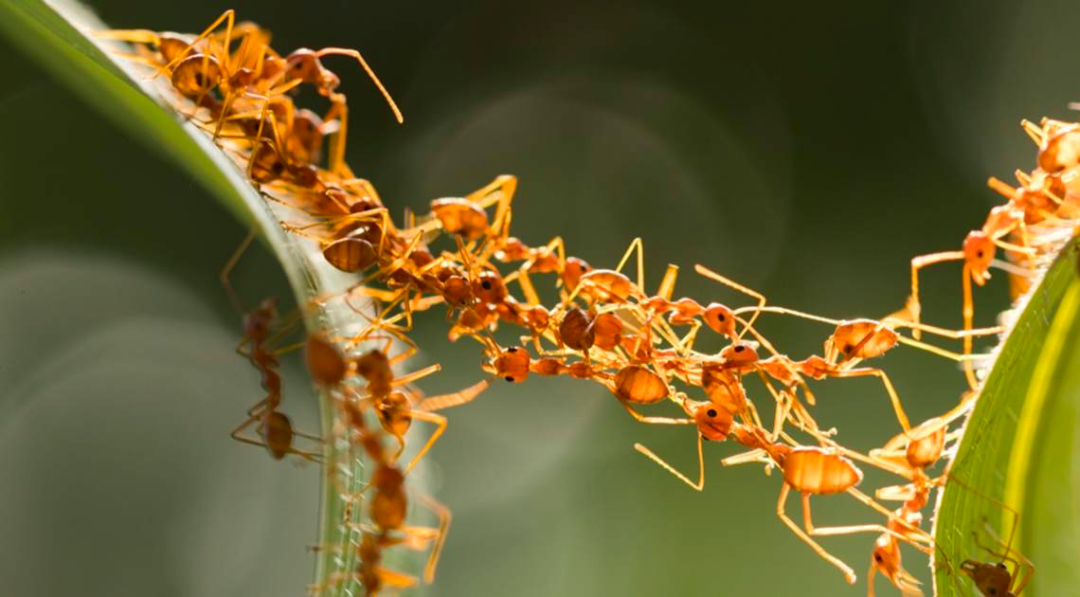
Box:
0, 0, 1080, 596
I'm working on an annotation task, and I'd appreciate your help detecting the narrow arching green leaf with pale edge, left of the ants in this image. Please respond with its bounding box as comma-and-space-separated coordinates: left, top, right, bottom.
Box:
0, 0, 399, 595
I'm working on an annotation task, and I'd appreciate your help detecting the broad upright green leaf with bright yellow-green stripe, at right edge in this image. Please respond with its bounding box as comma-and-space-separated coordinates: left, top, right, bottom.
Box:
934, 240, 1080, 596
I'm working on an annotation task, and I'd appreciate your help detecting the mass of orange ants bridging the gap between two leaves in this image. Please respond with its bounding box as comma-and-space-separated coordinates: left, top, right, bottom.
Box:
96, 11, 1080, 596
